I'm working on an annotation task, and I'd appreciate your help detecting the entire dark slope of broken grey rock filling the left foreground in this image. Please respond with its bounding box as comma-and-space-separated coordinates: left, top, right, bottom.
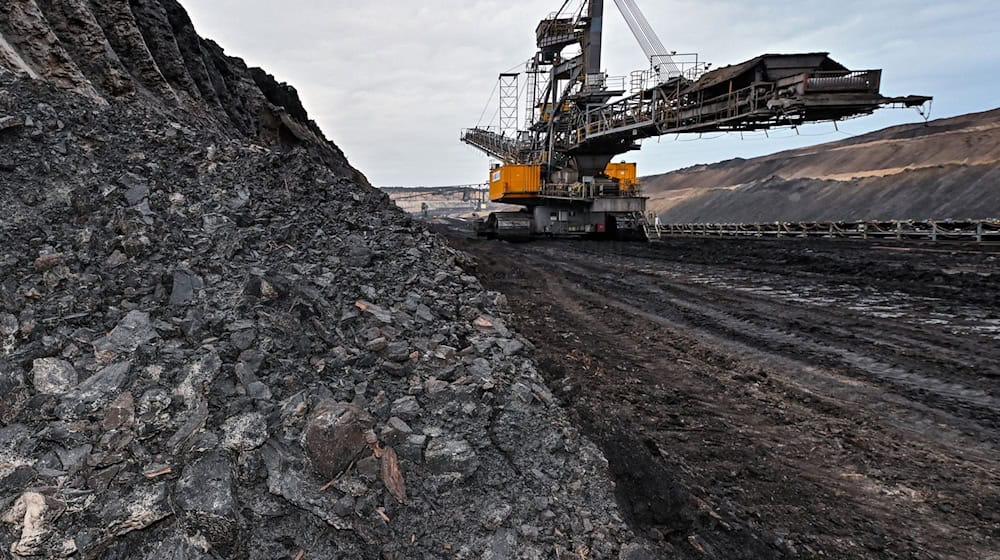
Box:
0, 0, 650, 560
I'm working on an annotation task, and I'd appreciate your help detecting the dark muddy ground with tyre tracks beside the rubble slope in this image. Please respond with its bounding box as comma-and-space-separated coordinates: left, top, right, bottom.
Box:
453, 229, 1000, 560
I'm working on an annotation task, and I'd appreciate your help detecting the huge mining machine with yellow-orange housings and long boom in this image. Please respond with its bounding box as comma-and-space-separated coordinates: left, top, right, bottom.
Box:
461, 0, 931, 239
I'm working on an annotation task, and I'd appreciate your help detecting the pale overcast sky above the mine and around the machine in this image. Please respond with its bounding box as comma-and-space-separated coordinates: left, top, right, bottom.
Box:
181, 0, 1000, 186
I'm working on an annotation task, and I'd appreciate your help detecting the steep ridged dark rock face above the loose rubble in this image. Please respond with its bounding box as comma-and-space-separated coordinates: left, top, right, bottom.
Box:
0, 0, 367, 184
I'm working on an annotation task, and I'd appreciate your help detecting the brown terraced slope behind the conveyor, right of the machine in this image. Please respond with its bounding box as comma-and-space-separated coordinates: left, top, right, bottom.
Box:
644, 109, 1000, 223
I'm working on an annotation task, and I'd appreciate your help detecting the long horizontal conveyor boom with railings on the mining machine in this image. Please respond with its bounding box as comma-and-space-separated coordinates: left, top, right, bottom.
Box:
461, 53, 931, 164
